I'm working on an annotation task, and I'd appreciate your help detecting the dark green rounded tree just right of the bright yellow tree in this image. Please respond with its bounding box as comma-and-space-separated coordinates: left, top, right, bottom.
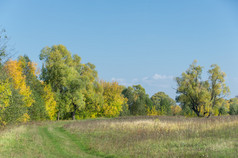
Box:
122, 85, 153, 115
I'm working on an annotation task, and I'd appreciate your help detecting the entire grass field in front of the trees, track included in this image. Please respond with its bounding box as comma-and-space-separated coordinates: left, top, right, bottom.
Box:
0, 116, 238, 157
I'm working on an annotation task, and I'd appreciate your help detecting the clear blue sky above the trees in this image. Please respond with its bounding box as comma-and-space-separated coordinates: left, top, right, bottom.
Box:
0, 0, 238, 98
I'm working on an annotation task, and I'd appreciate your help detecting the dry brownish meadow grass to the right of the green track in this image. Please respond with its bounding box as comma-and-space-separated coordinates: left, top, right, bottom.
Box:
65, 116, 238, 157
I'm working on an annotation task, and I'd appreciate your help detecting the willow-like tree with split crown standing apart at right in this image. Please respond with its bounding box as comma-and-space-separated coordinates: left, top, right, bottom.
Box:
176, 61, 229, 116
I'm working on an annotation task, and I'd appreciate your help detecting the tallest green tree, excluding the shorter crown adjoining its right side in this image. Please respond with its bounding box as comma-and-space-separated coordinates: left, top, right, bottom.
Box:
40, 45, 83, 120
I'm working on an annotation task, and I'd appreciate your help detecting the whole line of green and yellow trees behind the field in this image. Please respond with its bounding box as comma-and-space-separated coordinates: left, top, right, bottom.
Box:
0, 30, 238, 126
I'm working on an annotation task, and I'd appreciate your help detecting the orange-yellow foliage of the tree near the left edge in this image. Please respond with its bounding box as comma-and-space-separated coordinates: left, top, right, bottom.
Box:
4, 60, 34, 122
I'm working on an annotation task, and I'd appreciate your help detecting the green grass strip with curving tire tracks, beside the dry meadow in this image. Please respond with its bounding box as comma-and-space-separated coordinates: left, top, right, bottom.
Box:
0, 122, 111, 158
